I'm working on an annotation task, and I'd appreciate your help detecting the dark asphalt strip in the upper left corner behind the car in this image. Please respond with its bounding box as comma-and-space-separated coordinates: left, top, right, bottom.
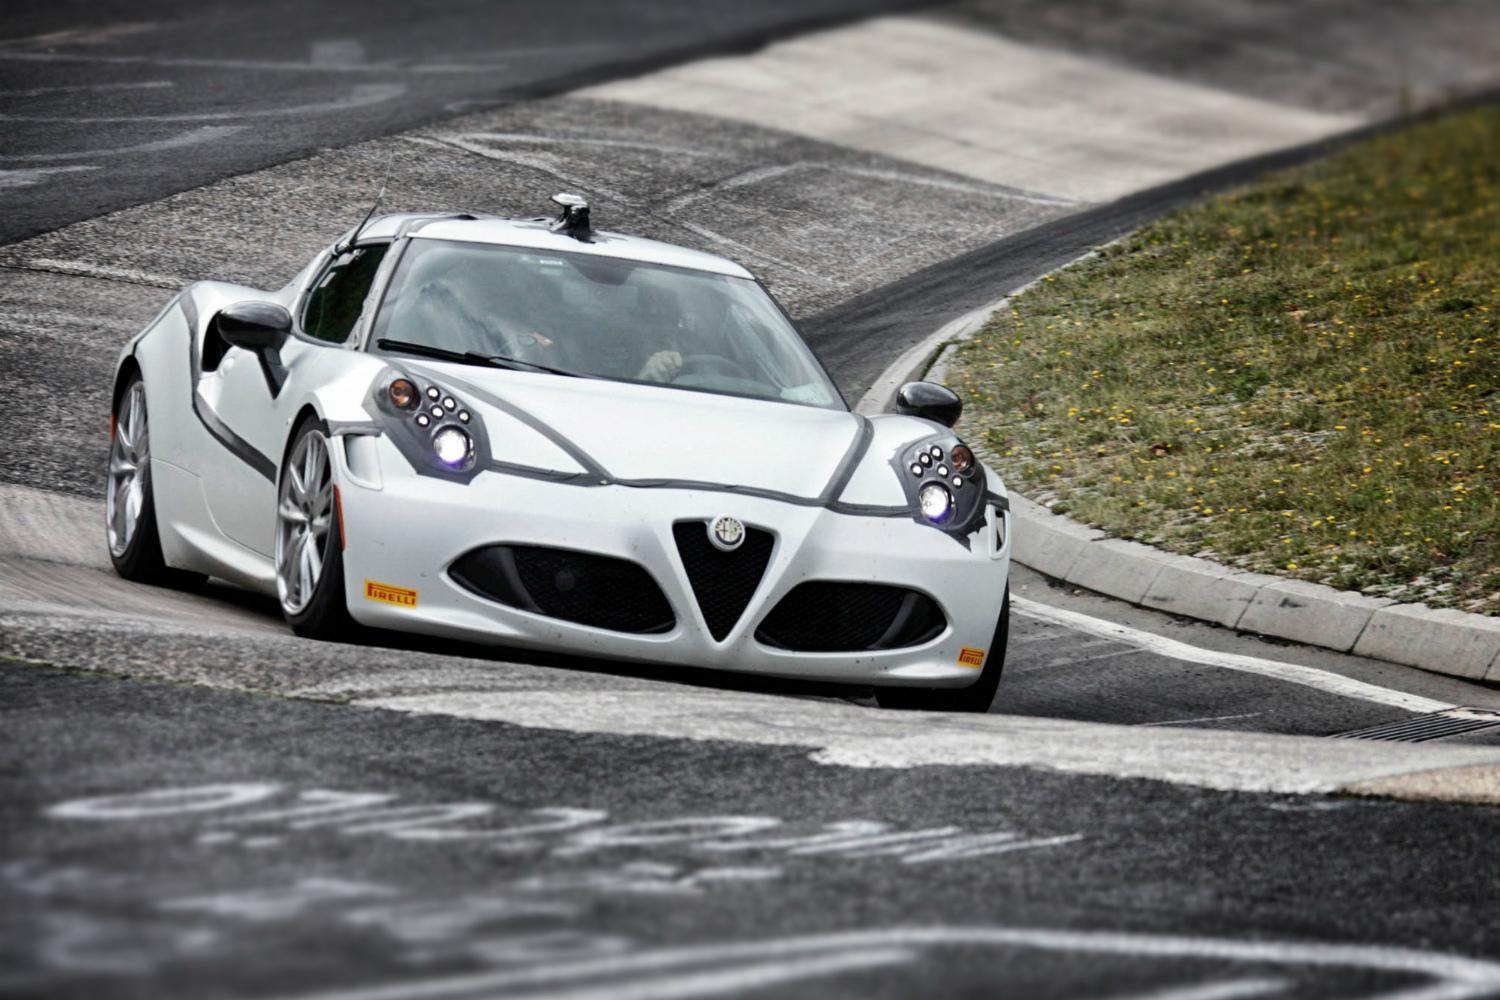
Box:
0, 0, 915, 243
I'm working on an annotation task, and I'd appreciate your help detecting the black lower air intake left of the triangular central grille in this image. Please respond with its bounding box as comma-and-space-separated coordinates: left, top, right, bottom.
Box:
449, 546, 677, 634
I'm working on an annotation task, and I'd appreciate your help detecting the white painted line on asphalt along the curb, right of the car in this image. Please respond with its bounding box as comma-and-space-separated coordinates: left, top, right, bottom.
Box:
1011, 597, 1454, 712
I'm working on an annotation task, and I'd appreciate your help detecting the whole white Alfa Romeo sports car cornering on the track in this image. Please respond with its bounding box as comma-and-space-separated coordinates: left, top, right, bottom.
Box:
107, 195, 1010, 711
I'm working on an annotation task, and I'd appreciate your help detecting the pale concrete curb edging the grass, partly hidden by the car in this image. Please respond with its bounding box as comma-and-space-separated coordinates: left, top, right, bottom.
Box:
855, 295, 1500, 682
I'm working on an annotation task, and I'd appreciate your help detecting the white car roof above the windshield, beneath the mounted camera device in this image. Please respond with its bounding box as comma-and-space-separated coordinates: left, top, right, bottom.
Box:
349, 213, 753, 277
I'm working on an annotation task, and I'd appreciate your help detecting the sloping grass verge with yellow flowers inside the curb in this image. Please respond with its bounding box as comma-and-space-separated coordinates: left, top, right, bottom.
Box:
948, 106, 1500, 615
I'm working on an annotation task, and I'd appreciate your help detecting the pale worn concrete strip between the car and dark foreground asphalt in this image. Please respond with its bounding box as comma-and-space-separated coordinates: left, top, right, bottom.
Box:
360, 683, 1500, 795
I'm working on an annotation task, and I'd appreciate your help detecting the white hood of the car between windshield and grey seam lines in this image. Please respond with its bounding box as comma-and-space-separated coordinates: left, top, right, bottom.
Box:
434, 366, 864, 498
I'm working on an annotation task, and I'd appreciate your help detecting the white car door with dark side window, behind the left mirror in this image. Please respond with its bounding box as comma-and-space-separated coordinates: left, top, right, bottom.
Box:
198, 243, 390, 558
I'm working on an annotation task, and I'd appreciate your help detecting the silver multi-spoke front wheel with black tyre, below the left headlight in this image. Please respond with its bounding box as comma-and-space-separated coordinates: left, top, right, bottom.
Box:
276, 418, 359, 642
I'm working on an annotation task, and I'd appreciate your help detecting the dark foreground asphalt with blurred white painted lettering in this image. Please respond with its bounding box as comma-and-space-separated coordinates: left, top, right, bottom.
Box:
0, 667, 1500, 1000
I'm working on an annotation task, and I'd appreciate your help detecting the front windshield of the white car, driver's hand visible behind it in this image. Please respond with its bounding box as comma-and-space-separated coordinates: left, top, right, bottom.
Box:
374, 238, 843, 409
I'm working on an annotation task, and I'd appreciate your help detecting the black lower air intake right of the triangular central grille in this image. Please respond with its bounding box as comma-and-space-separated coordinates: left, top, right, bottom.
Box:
755, 580, 948, 652
